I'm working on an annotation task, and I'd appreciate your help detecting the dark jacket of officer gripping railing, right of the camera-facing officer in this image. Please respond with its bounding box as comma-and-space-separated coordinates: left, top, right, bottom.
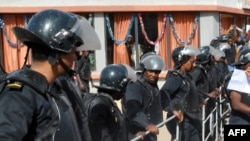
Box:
161, 70, 201, 123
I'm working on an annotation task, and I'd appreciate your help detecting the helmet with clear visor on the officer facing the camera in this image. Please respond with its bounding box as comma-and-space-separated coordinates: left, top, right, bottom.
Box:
140, 52, 165, 71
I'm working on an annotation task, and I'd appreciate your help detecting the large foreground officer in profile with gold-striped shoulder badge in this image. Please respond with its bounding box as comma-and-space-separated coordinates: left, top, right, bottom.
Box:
0, 9, 98, 141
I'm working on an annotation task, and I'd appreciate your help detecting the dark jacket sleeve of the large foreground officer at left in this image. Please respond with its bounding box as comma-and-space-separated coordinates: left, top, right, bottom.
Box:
0, 91, 36, 140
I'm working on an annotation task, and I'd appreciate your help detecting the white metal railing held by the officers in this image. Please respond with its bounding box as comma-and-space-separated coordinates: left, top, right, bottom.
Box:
130, 95, 231, 141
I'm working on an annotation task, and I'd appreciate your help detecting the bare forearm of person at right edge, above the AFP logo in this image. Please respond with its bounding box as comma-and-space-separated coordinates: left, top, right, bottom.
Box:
230, 91, 250, 115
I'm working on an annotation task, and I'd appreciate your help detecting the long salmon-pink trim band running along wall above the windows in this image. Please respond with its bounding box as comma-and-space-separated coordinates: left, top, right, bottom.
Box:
0, 5, 250, 16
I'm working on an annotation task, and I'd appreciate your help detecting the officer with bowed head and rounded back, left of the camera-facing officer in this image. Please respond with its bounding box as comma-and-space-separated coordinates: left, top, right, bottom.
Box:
83, 64, 136, 141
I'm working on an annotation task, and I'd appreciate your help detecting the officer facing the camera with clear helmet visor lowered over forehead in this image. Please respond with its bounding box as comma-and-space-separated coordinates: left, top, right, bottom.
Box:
122, 52, 165, 141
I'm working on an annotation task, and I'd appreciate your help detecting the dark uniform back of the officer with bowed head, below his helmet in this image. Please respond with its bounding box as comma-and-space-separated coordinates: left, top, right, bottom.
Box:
83, 92, 128, 141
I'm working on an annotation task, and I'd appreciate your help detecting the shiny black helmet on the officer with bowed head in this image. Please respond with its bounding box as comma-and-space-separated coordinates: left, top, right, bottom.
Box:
95, 64, 136, 92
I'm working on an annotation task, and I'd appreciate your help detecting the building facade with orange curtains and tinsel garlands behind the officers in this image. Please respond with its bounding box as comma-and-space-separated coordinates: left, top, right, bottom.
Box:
0, 0, 250, 79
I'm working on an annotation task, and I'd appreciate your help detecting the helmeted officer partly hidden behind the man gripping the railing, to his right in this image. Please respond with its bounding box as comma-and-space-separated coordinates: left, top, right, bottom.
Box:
189, 46, 222, 139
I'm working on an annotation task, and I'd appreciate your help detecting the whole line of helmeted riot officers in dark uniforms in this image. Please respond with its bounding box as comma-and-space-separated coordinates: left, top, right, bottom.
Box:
0, 9, 250, 141
